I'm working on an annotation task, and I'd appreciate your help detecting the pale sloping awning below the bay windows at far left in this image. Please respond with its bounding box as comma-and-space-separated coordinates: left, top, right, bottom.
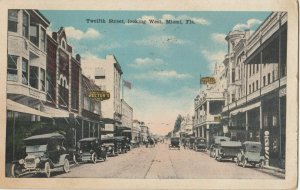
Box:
6, 99, 52, 118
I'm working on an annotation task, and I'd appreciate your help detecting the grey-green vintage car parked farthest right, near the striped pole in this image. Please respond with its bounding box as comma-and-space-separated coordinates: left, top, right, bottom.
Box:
236, 141, 264, 168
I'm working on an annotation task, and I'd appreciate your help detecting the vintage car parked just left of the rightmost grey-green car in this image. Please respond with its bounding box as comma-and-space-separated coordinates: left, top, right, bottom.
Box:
215, 141, 242, 161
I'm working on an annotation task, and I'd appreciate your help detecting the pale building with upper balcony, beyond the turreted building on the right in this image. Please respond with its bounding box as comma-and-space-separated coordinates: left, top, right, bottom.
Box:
193, 64, 226, 146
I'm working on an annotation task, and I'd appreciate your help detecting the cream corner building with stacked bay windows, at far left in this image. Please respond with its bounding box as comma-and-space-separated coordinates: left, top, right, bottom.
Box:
6, 9, 51, 161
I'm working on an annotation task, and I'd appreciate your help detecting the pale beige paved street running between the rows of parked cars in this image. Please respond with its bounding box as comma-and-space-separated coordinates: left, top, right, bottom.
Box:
54, 143, 276, 179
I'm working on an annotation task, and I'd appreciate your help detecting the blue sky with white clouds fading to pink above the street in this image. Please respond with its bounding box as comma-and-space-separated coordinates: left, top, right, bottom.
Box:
41, 10, 270, 135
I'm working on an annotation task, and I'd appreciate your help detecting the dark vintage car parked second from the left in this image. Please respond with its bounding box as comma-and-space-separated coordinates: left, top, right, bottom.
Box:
78, 137, 106, 164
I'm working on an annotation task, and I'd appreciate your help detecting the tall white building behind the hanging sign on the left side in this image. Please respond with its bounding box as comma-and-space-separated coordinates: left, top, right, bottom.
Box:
82, 55, 123, 135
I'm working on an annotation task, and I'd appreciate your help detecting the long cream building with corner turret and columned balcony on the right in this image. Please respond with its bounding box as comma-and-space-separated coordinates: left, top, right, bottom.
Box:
222, 12, 287, 168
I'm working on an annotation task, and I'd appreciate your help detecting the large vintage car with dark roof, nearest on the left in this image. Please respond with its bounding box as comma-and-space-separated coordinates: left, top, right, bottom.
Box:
11, 133, 70, 177
